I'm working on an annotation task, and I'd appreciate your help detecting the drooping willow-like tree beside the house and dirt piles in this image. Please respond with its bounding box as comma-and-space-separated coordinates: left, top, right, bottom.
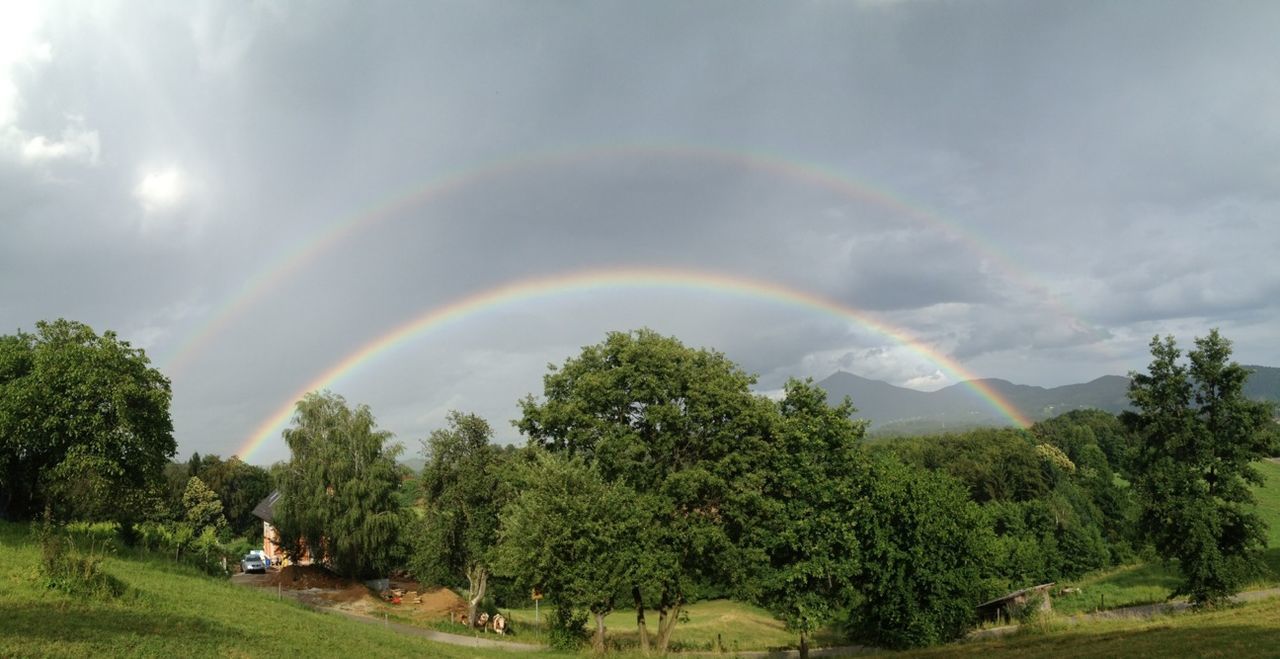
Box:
276, 392, 403, 577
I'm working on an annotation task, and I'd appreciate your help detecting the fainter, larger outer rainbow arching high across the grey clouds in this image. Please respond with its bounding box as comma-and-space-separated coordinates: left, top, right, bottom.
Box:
157, 143, 1089, 376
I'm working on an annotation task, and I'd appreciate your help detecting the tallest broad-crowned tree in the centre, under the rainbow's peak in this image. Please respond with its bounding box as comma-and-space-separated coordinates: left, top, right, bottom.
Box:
517, 330, 769, 651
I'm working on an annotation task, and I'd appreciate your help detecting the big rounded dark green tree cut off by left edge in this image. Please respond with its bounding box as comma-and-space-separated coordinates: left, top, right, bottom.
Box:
0, 320, 177, 521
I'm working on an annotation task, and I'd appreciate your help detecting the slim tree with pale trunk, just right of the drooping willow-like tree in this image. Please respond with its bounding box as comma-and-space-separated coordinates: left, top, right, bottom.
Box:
411, 411, 507, 624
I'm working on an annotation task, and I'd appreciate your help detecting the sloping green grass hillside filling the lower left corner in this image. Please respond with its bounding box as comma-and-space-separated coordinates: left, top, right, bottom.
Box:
0, 522, 545, 656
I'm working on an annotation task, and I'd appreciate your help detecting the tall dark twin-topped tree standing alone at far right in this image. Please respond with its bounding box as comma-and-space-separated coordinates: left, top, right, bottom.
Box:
1125, 329, 1274, 604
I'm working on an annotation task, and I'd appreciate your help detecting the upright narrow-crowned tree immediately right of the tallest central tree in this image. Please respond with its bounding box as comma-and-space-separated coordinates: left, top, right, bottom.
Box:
740, 380, 870, 658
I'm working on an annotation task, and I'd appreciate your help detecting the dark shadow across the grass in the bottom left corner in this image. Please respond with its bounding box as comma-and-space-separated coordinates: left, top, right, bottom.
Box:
0, 604, 239, 654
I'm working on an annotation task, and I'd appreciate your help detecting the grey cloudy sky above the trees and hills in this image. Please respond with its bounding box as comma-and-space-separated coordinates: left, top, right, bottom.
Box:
0, 0, 1280, 463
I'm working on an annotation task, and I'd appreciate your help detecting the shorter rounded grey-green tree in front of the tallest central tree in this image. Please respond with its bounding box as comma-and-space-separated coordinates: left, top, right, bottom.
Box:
498, 454, 652, 653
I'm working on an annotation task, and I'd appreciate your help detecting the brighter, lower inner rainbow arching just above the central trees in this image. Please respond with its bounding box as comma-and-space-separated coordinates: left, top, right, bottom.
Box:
236, 267, 1030, 459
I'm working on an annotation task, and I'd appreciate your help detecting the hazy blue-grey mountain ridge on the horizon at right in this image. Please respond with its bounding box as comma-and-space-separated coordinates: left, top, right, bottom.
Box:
818, 366, 1280, 435
